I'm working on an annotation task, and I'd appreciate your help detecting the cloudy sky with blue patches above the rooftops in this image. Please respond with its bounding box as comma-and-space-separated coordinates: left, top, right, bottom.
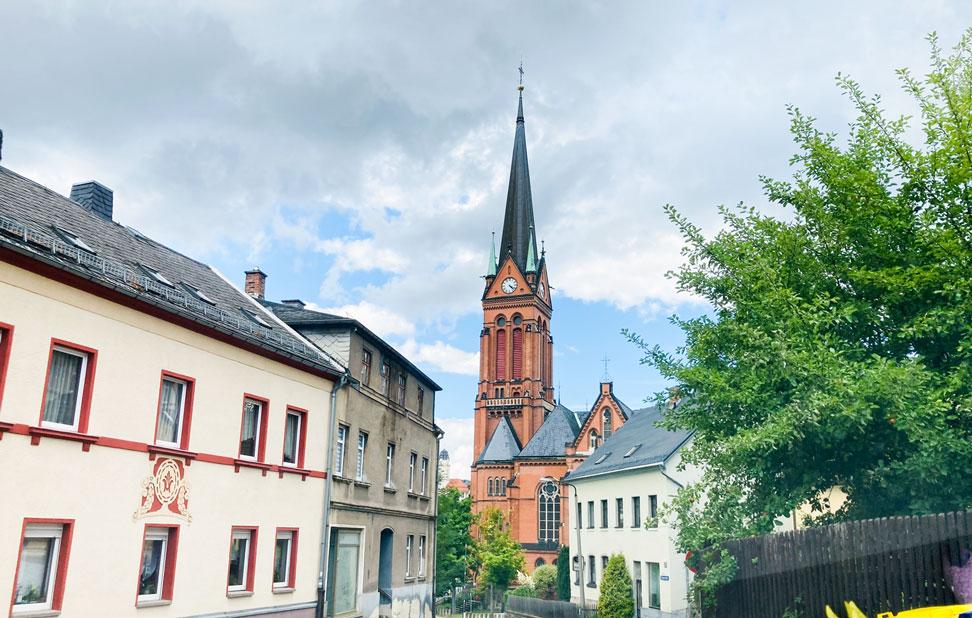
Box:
0, 0, 972, 476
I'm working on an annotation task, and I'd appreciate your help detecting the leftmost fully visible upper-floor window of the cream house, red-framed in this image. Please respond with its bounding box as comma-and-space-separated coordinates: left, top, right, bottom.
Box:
41, 342, 96, 433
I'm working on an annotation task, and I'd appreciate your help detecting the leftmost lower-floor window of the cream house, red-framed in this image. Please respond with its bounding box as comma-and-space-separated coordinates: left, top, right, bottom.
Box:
11, 519, 73, 615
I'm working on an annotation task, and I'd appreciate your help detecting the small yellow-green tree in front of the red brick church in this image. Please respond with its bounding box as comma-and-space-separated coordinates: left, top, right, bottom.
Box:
472, 508, 526, 598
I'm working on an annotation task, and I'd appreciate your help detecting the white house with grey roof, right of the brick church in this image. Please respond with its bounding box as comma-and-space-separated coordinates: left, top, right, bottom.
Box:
563, 407, 698, 618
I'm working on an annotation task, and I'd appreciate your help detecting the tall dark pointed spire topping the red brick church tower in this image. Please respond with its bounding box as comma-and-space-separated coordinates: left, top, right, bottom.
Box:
500, 67, 537, 271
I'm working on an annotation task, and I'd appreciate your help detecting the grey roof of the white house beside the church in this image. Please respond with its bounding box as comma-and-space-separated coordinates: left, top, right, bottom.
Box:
564, 406, 692, 481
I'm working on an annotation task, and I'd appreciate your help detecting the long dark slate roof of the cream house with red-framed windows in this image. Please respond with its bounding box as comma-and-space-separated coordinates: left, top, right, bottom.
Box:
0, 166, 343, 377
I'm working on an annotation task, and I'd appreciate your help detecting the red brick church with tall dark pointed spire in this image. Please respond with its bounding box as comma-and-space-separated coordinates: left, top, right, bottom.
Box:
471, 85, 632, 572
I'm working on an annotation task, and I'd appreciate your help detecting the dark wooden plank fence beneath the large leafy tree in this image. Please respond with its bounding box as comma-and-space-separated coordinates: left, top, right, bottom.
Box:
706, 511, 972, 618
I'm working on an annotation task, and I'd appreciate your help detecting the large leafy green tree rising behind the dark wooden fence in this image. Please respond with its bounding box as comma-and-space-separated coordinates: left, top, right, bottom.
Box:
627, 31, 972, 589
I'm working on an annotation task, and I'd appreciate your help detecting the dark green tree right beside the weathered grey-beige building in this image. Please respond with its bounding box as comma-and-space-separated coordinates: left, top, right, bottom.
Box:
435, 487, 472, 596
